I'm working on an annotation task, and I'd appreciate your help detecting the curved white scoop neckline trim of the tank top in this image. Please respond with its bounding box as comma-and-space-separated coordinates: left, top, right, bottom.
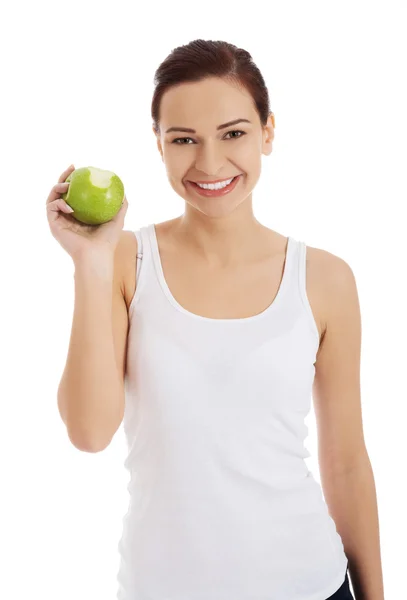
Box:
146, 223, 295, 323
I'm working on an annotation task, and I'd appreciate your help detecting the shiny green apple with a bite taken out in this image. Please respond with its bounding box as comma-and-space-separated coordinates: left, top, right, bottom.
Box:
62, 167, 124, 225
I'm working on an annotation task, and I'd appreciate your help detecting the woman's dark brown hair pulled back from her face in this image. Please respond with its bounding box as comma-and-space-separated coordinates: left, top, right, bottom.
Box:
151, 39, 271, 134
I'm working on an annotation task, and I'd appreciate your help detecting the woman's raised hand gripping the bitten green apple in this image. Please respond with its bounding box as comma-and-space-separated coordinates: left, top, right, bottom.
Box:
46, 166, 128, 261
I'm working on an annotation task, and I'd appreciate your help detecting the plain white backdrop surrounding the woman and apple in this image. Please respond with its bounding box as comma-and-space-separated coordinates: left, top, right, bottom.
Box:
0, 0, 407, 600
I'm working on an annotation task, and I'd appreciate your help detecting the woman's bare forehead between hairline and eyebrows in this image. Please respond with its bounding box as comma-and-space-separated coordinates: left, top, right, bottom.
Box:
160, 77, 256, 129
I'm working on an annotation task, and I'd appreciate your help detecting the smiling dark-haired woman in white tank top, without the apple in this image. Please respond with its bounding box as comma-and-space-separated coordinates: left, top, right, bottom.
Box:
47, 40, 383, 600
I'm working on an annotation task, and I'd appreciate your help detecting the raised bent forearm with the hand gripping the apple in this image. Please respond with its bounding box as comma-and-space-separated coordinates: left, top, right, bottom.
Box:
46, 165, 128, 452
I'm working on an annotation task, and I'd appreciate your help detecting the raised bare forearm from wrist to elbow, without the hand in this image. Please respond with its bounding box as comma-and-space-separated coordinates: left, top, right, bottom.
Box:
58, 241, 128, 452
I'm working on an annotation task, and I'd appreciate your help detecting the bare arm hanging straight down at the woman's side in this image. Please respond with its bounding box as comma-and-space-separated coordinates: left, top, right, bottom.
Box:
312, 252, 384, 600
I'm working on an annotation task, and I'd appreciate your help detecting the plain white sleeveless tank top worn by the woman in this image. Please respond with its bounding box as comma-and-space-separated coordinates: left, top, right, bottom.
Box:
117, 224, 348, 600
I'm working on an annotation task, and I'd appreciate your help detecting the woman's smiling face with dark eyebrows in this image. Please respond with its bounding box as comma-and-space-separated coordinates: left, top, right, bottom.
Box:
157, 77, 274, 215
